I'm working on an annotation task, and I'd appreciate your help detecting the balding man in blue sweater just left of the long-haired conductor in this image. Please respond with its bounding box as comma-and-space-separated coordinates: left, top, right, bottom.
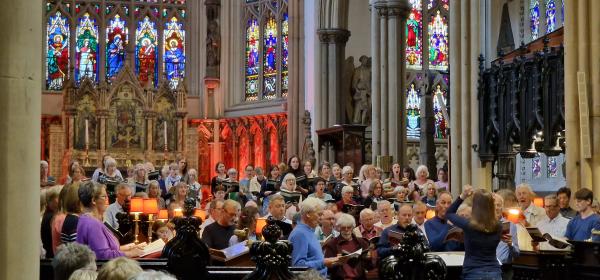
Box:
425, 192, 462, 252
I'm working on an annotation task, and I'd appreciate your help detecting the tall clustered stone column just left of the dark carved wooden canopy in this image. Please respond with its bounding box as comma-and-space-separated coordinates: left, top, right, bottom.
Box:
449, 0, 492, 195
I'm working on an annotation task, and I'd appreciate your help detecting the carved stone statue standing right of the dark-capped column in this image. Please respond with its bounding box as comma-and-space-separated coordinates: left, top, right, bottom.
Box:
352, 55, 371, 125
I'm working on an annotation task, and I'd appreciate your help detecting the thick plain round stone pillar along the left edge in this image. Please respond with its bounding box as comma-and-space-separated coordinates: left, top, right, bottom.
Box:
0, 0, 45, 279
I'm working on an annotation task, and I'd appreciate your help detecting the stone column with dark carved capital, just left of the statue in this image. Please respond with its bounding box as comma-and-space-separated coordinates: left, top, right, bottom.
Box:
317, 28, 350, 128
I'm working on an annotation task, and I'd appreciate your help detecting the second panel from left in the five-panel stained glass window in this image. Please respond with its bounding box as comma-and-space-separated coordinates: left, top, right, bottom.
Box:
75, 13, 98, 82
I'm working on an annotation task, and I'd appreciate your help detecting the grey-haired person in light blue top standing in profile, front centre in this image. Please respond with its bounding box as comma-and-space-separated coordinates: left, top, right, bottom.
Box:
289, 197, 347, 276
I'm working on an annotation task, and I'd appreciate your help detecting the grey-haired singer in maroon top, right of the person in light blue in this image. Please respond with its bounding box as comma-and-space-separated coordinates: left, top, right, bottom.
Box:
323, 214, 372, 279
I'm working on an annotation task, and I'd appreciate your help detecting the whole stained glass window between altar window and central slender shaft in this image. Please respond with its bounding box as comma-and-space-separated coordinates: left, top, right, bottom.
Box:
244, 0, 289, 101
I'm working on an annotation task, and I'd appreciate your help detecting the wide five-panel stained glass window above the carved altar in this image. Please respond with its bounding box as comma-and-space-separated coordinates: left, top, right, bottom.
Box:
43, 0, 188, 93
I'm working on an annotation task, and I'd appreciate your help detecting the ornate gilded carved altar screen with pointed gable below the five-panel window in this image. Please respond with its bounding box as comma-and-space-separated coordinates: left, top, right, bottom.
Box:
63, 65, 187, 167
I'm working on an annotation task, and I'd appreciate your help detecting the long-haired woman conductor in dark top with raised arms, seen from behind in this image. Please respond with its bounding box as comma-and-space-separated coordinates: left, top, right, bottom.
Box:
446, 185, 502, 280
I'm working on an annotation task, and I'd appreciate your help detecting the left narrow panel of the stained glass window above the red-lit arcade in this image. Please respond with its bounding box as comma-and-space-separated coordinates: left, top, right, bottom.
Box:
246, 18, 260, 101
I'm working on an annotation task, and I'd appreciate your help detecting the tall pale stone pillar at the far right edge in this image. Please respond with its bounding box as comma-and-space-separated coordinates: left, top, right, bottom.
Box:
564, 0, 600, 196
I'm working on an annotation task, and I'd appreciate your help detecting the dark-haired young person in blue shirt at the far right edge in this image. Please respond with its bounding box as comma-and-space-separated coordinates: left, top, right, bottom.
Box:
565, 188, 600, 241
